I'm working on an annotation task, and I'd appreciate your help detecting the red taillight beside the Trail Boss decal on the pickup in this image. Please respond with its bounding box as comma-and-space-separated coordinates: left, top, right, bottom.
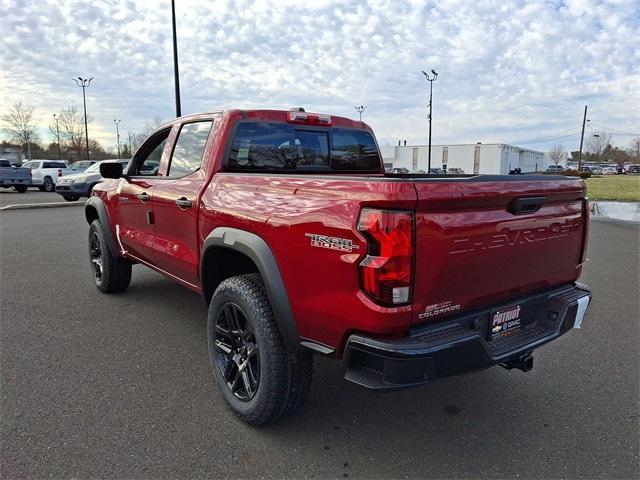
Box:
358, 208, 414, 306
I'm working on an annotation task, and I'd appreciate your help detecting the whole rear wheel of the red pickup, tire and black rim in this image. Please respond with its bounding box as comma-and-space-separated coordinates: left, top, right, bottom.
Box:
207, 274, 313, 425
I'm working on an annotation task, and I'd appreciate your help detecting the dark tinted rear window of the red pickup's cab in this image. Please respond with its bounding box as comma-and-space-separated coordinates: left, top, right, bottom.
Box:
227, 122, 380, 173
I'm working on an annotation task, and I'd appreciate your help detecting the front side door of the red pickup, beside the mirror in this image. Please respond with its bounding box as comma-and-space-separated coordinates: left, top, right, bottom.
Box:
116, 128, 171, 264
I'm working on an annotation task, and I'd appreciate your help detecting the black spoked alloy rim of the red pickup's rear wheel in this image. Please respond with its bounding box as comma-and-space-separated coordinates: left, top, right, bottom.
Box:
214, 302, 260, 402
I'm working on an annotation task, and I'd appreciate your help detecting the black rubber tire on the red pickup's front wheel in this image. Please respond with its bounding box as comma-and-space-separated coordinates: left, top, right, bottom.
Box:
89, 220, 131, 293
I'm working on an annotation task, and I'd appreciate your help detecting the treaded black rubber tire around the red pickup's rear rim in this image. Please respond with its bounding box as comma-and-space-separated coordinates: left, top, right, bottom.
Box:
207, 274, 313, 425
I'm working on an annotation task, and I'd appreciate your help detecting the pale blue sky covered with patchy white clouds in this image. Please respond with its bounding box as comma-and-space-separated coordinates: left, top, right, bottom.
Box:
0, 0, 640, 150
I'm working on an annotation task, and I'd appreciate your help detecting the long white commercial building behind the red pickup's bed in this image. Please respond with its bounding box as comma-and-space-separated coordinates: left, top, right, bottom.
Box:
380, 143, 551, 175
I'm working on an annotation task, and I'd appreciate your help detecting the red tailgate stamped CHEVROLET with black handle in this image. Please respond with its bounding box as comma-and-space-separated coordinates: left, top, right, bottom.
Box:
413, 177, 588, 323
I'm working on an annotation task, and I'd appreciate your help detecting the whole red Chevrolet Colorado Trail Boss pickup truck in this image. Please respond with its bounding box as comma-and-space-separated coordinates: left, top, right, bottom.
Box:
85, 109, 591, 424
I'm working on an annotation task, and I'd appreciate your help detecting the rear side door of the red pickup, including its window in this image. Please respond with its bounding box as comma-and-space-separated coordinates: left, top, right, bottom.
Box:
153, 120, 213, 288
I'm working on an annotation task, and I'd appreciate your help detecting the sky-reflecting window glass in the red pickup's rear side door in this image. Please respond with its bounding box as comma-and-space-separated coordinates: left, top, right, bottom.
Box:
168, 121, 212, 178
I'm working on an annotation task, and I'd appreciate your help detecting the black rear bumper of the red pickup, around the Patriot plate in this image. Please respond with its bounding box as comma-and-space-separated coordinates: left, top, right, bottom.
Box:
344, 283, 591, 390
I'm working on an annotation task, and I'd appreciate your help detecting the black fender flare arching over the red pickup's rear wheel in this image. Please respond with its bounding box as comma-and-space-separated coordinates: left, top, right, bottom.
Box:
200, 227, 300, 351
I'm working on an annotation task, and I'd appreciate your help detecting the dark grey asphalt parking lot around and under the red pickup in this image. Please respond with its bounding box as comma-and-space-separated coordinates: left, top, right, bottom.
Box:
0, 208, 640, 479
